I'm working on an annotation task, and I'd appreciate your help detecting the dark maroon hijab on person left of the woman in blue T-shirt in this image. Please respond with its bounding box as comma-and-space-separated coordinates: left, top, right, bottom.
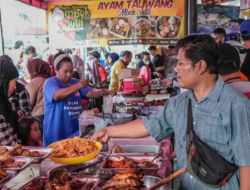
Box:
27, 59, 50, 80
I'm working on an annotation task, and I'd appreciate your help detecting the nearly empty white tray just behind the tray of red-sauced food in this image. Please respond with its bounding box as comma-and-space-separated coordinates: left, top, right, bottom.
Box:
112, 145, 160, 156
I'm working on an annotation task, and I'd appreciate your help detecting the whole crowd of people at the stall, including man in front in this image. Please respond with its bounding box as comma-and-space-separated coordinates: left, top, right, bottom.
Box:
0, 17, 250, 190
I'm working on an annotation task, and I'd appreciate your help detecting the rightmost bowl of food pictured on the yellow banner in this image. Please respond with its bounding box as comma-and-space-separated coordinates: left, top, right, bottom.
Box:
155, 16, 181, 38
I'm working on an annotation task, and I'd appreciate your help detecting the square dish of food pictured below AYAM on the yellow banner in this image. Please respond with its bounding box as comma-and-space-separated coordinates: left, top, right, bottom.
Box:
109, 18, 130, 38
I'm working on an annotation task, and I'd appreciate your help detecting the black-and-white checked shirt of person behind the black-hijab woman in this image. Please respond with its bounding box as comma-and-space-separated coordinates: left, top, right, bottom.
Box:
9, 83, 31, 118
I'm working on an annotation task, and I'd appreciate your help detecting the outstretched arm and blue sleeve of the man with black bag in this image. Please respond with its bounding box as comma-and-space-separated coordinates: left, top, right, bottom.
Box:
92, 100, 174, 143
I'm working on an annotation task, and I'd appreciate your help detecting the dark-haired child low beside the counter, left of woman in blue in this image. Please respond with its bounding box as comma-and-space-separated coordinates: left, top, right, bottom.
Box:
20, 117, 43, 147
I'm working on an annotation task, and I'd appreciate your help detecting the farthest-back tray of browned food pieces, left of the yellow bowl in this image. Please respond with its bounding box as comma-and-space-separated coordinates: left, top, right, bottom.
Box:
0, 144, 53, 163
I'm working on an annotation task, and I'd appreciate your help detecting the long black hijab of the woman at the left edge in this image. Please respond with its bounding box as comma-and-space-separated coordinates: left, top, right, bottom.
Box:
0, 57, 19, 138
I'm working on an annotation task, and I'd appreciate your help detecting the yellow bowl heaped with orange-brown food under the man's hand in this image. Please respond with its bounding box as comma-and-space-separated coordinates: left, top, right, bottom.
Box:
49, 137, 102, 164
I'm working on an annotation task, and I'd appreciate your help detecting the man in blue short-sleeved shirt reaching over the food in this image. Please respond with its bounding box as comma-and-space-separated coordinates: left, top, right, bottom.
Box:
93, 35, 250, 190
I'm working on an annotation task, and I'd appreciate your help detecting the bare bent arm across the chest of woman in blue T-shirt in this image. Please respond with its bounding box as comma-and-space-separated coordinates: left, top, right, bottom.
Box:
53, 79, 89, 101
